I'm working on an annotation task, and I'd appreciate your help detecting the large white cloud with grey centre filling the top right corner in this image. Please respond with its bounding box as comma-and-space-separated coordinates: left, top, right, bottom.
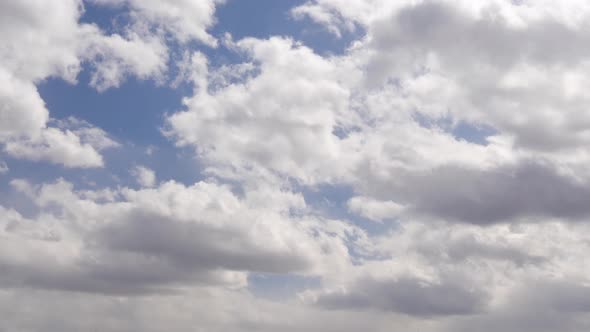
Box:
299, 0, 589, 152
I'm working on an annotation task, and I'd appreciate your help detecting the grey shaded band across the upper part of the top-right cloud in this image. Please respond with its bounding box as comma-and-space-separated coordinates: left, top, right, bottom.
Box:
372, 2, 590, 68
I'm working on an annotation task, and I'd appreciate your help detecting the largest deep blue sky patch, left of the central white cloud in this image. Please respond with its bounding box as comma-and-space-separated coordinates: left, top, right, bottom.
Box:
35, 71, 206, 186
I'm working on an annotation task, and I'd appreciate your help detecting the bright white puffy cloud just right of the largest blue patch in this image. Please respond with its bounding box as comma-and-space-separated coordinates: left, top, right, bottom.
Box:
168, 37, 360, 182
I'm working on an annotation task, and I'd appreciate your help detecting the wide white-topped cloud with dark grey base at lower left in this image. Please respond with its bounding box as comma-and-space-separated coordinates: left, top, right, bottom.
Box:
0, 180, 358, 295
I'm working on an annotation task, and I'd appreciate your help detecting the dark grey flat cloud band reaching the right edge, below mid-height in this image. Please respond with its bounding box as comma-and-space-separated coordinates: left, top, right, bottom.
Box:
366, 162, 590, 224
